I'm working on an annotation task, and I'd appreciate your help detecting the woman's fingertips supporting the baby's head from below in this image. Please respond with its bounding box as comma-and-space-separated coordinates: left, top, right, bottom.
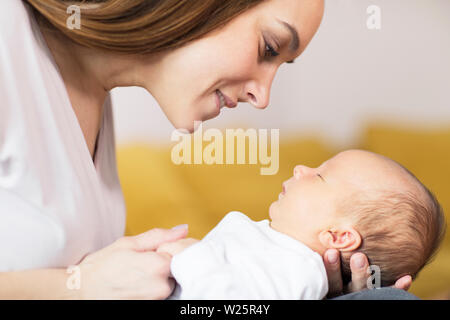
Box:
323, 249, 412, 298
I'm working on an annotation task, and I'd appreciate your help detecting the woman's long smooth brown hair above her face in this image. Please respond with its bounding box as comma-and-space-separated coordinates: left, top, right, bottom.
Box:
24, 0, 264, 54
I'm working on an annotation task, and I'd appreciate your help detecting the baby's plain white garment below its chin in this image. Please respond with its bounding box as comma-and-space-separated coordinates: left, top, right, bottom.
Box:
169, 211, 328, 300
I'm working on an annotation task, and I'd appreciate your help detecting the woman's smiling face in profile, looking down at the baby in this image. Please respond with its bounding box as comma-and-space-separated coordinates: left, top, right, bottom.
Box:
142, 0, 324, 132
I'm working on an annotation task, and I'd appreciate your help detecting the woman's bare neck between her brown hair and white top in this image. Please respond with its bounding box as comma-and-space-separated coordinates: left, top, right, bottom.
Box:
37, 22, 163, 157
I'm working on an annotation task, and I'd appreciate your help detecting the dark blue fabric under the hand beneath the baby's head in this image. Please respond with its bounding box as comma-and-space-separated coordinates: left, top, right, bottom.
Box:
331, 288, 420, 300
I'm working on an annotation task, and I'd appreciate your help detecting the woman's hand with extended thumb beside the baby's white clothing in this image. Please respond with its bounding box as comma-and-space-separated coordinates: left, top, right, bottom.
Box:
79, 228, 188, 299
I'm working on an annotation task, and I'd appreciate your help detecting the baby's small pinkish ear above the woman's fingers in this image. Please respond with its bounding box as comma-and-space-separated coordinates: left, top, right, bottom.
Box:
319, 227, 362, 252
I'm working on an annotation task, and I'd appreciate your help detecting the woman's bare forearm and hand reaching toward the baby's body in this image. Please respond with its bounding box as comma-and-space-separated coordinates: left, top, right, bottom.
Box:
0, 228, 187, 299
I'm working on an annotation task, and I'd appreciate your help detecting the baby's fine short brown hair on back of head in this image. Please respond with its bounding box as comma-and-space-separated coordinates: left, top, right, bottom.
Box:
340, 181, 446, 287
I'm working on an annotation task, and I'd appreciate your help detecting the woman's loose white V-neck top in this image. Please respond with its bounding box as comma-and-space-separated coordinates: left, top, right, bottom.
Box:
0, 0, 125, 271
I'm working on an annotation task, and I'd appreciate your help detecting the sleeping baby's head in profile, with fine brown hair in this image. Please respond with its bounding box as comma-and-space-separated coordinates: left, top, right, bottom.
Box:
269, 150, 445, 286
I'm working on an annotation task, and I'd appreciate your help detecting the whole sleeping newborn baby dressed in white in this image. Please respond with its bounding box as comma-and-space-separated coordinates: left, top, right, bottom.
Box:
158, 150, 445, 299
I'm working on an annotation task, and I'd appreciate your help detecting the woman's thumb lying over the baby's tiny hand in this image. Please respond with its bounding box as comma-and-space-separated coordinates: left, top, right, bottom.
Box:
131, 224, 188, 251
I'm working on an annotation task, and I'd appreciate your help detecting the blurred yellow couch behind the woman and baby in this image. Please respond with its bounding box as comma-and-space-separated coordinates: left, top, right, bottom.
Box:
117, 125, 450, 298
